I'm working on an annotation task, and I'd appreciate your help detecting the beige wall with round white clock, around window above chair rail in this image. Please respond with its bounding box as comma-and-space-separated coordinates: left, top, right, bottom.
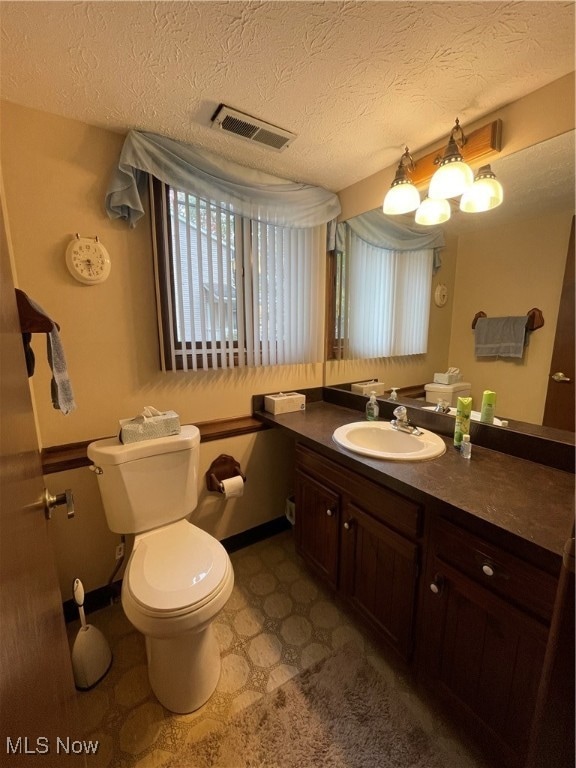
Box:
1, 102, 323, 447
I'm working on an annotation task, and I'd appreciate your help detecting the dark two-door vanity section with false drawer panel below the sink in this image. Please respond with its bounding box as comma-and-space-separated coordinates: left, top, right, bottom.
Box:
296, 446, 421, 660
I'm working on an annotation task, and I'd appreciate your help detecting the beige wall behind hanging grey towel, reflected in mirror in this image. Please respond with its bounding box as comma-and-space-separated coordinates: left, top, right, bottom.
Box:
450, 209, 574, 424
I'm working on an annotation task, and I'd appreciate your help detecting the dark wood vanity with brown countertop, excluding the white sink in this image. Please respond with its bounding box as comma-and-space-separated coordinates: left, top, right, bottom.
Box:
257, 402, 574, 767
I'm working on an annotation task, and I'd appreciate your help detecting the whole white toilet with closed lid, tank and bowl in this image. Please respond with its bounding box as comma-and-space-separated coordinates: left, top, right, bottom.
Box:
88, 426, 234, 713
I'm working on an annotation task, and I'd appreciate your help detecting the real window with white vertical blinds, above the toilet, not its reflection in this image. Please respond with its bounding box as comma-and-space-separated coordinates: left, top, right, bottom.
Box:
152, 179, 326, 370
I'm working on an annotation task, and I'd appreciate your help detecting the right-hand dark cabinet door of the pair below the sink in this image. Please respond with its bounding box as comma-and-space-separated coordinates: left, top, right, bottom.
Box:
341, 503, 418, 660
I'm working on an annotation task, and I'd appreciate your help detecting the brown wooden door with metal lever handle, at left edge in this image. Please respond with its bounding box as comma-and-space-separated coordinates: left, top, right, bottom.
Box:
0, 189, 85, 768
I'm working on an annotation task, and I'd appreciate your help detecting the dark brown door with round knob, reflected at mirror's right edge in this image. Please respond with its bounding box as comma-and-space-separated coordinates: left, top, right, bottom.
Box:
542, 218, 575, 432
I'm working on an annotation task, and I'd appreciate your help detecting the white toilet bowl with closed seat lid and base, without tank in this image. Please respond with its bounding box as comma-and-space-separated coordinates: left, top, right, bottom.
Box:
122, 520, 234, 713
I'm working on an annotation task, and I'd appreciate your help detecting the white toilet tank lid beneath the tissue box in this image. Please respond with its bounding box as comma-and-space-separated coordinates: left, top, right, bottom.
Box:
86, 424, 200, 464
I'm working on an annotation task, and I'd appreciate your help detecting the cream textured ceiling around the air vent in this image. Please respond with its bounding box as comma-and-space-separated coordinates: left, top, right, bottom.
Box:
0, 0, 574, 191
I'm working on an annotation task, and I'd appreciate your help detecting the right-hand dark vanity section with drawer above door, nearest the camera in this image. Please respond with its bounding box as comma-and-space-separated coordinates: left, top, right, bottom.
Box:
418, 518, 557, 766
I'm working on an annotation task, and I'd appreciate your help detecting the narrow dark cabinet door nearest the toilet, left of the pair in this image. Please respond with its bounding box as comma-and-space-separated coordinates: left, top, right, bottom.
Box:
295, 470, 340, 588
